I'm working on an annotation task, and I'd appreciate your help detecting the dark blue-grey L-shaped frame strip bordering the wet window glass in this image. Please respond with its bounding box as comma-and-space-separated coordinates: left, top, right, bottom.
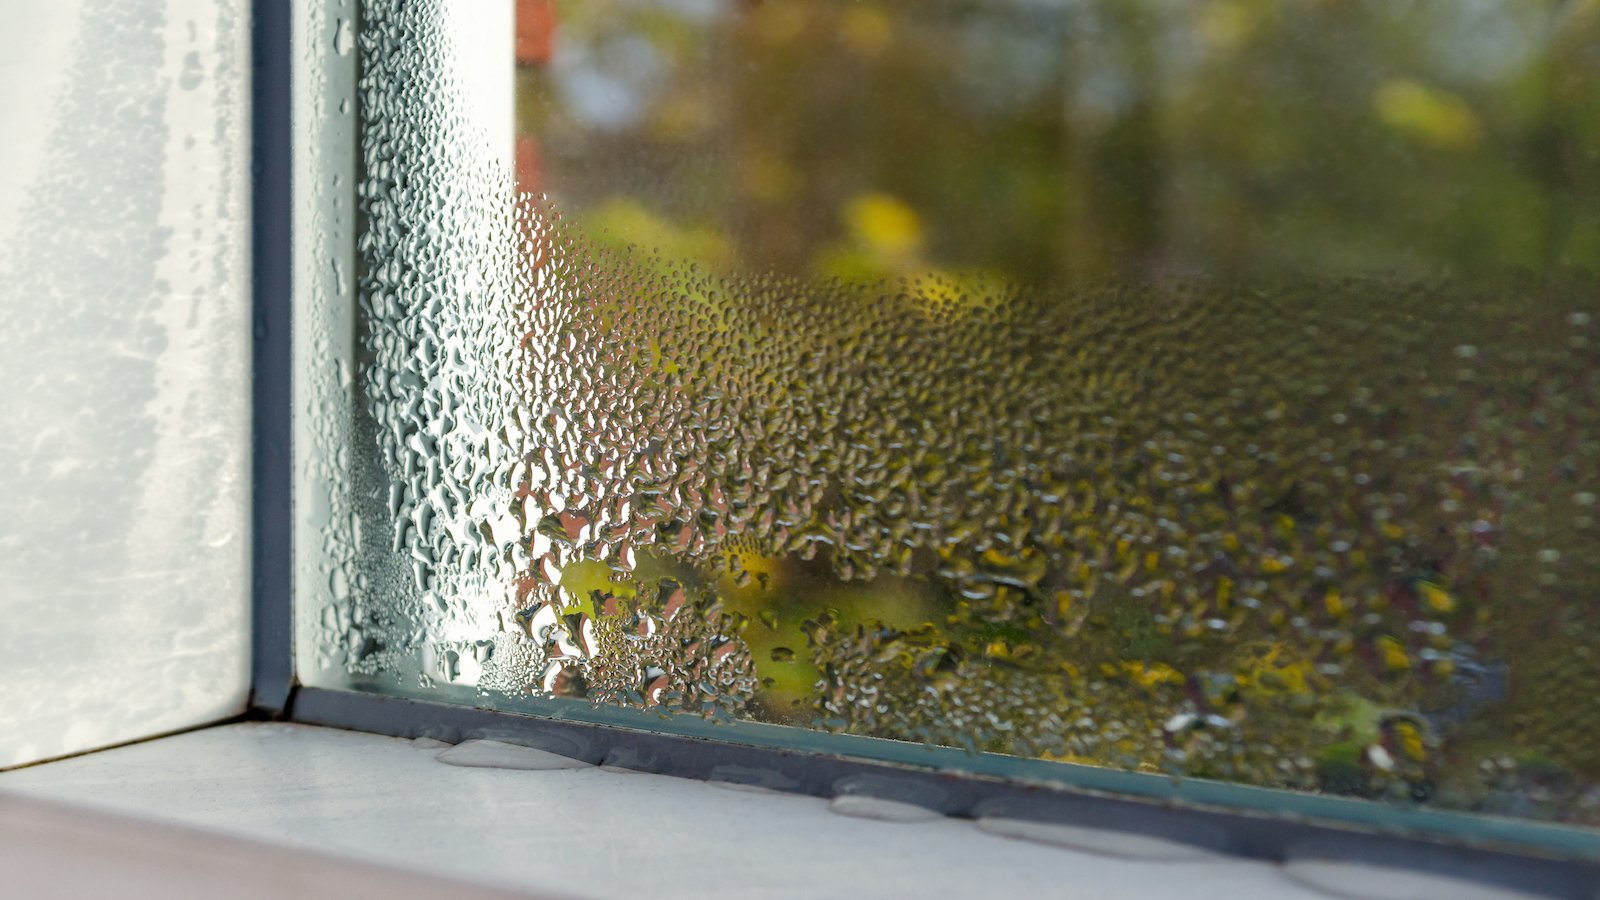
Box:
250, 0, 1600, 897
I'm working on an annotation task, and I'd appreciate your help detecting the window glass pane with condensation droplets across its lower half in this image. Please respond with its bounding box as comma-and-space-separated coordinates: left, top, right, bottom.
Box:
302, 0, 1600, 823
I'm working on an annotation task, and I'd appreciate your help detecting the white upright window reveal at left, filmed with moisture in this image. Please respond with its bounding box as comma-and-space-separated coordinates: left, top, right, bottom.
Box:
0, 0, 250, 767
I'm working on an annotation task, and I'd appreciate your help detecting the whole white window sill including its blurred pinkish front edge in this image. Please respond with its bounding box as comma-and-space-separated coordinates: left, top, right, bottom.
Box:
0, 724, 1536, 900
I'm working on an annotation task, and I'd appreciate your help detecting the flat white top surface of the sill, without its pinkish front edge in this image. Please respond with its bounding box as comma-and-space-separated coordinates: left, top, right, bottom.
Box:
0, 724, 1318, 900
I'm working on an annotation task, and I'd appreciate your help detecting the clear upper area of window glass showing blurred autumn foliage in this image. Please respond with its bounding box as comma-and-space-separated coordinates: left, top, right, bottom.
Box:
517, 0, 1600, 282
